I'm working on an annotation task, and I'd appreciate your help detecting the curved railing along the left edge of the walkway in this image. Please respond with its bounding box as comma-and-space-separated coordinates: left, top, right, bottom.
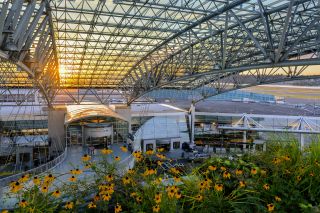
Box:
0, 146, 68, 187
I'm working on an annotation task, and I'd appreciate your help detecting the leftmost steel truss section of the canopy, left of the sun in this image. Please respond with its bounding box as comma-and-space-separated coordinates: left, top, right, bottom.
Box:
0, 0, 59, 104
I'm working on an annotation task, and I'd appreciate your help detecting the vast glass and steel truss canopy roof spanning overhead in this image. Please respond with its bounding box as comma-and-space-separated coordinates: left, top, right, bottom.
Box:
0, 0, 320, 103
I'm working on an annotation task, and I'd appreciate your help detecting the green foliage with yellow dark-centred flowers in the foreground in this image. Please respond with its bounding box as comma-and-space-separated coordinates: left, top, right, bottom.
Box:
4, 139, 320, 213
